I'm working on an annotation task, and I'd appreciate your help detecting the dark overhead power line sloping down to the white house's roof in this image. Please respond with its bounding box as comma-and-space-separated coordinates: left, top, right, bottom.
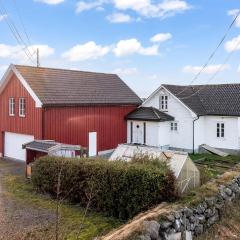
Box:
176, 10, 240, 96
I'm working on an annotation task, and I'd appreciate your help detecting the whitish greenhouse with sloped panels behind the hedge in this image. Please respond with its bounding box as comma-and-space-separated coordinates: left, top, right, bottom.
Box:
109, 144, 200, 194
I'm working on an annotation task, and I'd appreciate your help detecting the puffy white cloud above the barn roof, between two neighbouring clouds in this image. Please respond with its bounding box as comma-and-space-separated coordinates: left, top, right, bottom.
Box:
62, 41, 110, 62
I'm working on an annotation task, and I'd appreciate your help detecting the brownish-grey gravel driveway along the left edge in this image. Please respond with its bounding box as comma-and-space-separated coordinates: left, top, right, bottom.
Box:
0, 159, 54, 240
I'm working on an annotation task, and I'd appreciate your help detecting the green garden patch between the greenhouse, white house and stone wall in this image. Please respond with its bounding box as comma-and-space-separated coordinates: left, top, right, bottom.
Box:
190, 153, 240, 184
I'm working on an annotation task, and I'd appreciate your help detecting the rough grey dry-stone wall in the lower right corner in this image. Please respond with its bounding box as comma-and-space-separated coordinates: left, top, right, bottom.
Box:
136, 176, 240, 240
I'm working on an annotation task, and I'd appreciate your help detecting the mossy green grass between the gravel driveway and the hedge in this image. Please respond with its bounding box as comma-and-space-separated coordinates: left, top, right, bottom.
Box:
0, 161, 121, 240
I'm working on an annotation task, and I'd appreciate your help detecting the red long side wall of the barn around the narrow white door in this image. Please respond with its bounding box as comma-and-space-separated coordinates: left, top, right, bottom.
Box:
44, 106, 136, 151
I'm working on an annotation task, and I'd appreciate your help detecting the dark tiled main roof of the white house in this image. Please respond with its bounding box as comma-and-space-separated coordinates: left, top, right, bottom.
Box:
163, 84, 240, 116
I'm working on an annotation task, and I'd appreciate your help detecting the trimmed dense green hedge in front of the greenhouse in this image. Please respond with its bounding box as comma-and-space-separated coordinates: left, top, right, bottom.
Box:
32, 157, 175, 219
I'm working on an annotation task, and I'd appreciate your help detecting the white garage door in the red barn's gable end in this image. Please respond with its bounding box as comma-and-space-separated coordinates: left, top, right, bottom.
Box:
4, 132, 34, 161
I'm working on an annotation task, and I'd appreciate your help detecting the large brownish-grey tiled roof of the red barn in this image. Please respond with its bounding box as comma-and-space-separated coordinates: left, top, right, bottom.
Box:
15, 65, 142, 106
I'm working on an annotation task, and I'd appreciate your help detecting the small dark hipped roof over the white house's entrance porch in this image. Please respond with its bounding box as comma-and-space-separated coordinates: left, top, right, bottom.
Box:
126, 107, 174, 122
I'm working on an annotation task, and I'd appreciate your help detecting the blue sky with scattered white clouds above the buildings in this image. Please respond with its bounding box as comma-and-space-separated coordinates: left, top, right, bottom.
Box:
0, 0, 240, 97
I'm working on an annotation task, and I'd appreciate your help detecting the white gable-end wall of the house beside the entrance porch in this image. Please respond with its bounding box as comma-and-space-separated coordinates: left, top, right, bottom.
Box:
143, 89, 196, 150
